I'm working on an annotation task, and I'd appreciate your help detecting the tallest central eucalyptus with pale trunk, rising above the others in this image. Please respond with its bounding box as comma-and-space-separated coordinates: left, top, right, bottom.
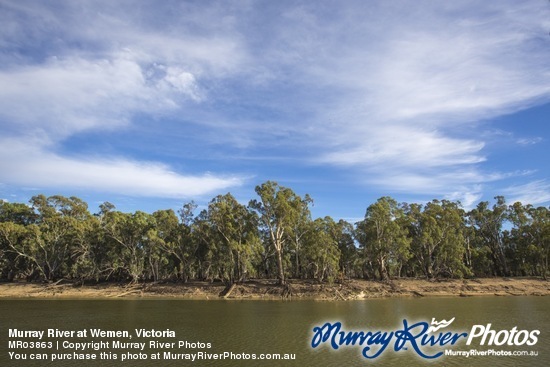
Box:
249, 181, 311, 284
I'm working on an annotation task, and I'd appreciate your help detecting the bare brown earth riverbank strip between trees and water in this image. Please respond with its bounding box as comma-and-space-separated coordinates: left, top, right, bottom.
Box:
0, 278, 550, 301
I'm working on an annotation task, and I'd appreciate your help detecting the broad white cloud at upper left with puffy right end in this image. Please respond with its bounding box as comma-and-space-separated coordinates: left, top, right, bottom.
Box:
0, 51, 208, 138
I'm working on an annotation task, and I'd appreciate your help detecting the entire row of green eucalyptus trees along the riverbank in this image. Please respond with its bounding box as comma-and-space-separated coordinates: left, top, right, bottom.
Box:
0, 181, 550, 284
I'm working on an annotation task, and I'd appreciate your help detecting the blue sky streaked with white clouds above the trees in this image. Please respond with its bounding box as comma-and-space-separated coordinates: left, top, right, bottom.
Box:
0, 0, 550, 221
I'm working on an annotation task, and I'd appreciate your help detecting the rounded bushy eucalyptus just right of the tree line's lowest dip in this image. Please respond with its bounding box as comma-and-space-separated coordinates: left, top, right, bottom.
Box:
356, 196, 410, 280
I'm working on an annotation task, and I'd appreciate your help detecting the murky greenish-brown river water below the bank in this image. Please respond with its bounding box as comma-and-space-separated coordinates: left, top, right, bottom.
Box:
0, 297, 550, 367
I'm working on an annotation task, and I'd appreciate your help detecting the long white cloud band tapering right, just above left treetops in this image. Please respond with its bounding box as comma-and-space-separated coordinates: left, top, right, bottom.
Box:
0, 139, 244, 198
